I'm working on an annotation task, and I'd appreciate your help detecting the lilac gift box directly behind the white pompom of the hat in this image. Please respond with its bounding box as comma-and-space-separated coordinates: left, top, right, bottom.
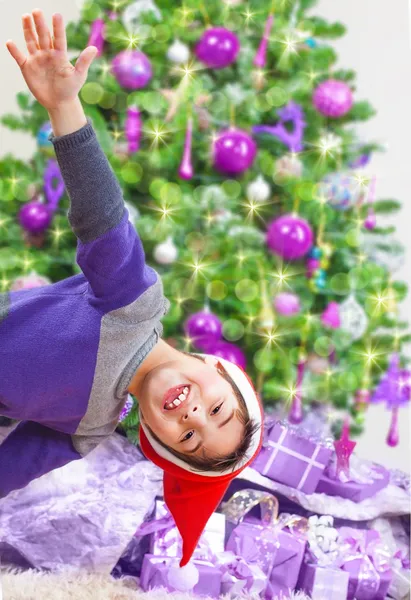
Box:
140, 554, 222, 598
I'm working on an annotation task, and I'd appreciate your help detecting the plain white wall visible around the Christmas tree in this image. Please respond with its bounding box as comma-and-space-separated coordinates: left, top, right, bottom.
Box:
0, 0, 411, 472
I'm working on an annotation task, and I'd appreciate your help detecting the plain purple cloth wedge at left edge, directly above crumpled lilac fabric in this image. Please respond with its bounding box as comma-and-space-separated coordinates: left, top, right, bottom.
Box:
0, 421, 82, 498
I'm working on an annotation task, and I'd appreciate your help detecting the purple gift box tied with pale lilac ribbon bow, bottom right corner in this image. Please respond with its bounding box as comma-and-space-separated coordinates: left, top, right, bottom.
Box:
339, 527, 393, 600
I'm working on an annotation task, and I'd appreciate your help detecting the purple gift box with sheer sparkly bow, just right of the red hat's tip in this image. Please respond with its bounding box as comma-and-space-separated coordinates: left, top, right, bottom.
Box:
227, 517, 306, 600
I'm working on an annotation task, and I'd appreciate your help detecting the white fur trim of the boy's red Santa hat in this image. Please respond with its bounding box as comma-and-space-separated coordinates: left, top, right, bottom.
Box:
140, 352, 262, 477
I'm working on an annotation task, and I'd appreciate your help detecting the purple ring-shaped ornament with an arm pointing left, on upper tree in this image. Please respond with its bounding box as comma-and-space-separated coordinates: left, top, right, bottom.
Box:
253, 101, 306, 152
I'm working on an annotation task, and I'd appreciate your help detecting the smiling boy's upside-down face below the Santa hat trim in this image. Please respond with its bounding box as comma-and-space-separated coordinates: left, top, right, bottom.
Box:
139, 355, 248, 456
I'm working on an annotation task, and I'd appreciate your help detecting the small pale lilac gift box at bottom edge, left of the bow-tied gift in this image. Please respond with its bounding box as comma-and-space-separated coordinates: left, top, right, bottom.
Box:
297, 562, 349, 600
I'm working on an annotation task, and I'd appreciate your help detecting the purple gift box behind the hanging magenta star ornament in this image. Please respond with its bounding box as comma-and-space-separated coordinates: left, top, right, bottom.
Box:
316, 455, 390, 502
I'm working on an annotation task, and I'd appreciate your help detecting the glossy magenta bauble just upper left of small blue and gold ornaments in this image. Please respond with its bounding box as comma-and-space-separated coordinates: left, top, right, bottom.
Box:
266, 214, 314, 260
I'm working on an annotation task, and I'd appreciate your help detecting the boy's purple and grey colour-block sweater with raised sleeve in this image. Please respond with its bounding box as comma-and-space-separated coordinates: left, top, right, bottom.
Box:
0, 117, 170, 498
